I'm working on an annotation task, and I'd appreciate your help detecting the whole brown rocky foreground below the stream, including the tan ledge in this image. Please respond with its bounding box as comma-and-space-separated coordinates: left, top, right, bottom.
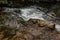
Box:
0, 14, 60, 40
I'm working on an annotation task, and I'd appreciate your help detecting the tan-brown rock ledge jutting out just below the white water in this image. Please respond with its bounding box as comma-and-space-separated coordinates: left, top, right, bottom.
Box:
29, 19, 55, 29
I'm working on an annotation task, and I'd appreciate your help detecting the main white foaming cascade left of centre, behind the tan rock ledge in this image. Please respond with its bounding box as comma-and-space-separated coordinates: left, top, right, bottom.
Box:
3, 7, 44, 21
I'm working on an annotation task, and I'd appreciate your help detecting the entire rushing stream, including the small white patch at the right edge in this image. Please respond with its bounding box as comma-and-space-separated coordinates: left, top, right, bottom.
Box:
4, 7, 60, 31
